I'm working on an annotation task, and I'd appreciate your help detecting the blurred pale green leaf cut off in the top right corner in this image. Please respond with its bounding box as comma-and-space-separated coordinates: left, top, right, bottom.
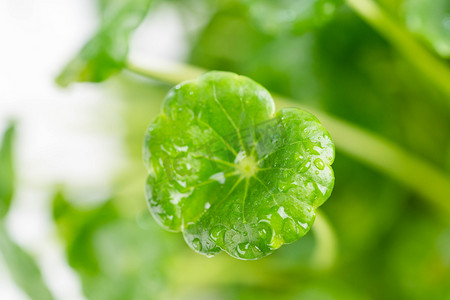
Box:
404, 0, 450, 58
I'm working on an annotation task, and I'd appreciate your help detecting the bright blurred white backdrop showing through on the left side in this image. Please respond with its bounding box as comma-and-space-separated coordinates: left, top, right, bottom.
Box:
0, 0, 186, 300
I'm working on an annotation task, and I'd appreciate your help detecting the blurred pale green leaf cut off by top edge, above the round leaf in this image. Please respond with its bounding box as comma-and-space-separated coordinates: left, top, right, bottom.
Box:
243, 0, 342, 34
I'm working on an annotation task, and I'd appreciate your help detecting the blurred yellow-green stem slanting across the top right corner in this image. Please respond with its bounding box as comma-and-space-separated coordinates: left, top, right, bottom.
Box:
346, 0, 450, 102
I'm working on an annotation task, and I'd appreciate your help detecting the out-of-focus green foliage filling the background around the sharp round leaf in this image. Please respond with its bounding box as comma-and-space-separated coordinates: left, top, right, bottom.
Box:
0, 0, 450, 300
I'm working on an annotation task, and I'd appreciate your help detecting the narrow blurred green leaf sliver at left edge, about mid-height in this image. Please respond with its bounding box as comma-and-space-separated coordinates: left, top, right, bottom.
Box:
0, 124, 15, 219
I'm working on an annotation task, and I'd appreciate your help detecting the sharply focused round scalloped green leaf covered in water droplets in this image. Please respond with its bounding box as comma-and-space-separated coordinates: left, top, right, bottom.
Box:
144, 72, 334, 259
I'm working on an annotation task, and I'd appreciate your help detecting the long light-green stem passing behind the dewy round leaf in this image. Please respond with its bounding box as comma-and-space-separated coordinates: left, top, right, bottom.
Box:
127, 59, 450, 220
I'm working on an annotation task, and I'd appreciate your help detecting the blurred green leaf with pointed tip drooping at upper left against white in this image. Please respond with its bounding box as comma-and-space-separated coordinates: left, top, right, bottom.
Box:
56, 0, 152, 86
